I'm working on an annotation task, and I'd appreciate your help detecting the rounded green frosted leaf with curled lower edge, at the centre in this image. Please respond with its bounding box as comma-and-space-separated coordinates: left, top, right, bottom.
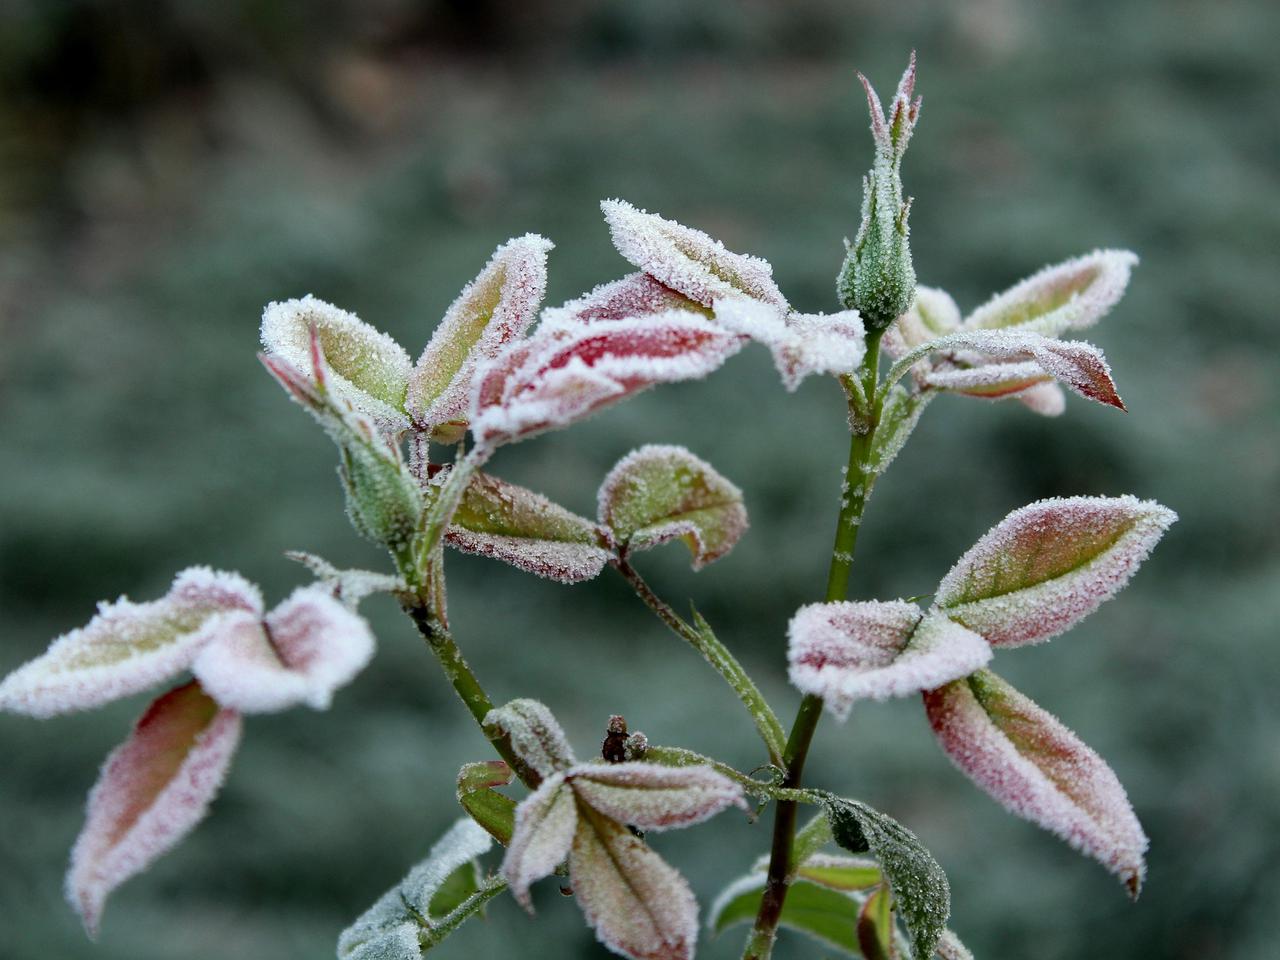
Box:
598, 444, 746, 570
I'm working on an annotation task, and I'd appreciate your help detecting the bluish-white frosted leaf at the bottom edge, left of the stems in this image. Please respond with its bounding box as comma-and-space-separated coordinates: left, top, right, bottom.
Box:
338, 819, 493, 960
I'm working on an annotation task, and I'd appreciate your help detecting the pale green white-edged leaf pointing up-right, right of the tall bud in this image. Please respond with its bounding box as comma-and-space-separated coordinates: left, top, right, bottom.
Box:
964, 250, 1138, 337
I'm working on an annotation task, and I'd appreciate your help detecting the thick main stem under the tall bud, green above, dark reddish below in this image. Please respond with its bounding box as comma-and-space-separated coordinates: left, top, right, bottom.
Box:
742, 333, 882, 960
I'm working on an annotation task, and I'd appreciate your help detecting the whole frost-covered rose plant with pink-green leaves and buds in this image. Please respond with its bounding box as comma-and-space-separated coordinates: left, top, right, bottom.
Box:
0, 56, 1175, 960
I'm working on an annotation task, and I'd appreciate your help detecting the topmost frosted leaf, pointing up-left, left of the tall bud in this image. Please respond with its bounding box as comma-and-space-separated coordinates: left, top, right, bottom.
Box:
600, 200, 788, 311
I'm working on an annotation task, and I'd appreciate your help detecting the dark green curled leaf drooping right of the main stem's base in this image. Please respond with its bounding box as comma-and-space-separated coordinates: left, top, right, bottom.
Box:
812, 790, 951, 957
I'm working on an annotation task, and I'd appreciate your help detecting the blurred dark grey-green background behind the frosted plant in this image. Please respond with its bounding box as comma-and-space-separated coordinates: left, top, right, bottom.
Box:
0, 0, 1280, 960
